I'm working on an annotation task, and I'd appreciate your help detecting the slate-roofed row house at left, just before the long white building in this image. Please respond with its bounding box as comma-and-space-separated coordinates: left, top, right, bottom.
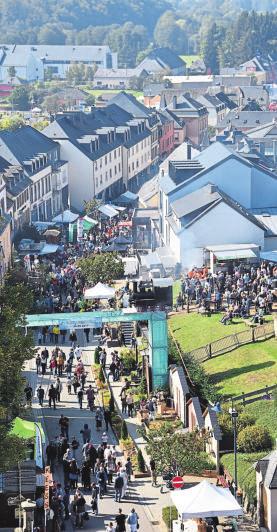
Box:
0, 126, 68, 223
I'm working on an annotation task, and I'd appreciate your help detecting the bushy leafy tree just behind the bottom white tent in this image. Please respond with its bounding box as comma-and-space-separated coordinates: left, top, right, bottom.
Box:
144, 423, 209, 475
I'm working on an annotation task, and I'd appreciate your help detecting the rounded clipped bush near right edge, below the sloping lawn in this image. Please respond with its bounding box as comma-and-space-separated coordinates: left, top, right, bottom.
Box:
238, 425, 272, 453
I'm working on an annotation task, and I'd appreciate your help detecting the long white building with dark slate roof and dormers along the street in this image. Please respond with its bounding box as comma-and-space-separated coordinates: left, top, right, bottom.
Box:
44, 104, 152, 211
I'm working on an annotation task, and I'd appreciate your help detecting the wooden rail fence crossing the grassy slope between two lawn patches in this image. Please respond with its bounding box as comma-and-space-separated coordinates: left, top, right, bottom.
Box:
183, 321, 275, 362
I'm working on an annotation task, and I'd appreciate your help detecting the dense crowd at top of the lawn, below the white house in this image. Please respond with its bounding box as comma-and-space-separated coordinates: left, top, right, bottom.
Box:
176, 263, 277, 324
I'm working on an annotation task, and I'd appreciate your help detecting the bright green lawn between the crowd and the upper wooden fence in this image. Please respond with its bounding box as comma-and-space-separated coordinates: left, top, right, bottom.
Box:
169, 312, 247, 352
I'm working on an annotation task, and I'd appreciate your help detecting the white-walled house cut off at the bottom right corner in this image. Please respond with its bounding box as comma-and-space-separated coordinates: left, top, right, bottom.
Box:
256, 451, 277, 532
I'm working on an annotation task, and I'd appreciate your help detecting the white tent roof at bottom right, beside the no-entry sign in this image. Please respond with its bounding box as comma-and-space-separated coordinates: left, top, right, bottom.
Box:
170, 480, 243, 519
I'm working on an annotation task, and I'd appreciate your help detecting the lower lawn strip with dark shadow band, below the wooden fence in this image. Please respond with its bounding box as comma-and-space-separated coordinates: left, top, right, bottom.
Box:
204, 338, 277, 396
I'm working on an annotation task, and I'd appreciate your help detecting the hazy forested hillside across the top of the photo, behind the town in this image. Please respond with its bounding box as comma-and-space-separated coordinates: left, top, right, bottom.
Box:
0, 0, 277, 68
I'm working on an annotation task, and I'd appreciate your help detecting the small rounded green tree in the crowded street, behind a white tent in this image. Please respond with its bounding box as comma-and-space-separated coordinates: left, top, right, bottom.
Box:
78, 253, 124, 285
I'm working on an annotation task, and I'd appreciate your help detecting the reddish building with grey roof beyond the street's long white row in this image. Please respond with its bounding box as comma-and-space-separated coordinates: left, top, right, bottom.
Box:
162, 93, 208, 146
